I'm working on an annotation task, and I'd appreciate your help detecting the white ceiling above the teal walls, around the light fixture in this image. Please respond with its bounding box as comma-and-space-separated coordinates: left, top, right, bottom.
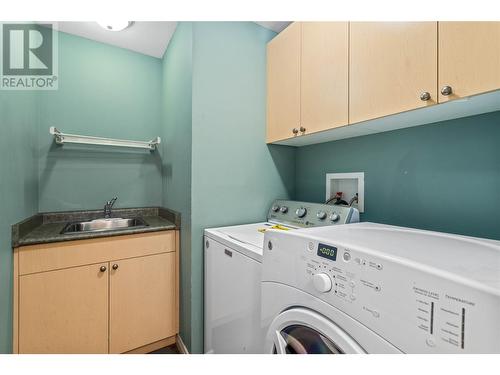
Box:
52, 21, 290, 58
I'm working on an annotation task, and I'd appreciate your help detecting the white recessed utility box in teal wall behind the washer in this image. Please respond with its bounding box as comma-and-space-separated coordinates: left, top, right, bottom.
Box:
325, 172, 365, 212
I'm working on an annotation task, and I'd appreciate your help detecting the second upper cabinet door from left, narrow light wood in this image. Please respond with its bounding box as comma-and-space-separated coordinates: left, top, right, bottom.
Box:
299, 22, 349, 134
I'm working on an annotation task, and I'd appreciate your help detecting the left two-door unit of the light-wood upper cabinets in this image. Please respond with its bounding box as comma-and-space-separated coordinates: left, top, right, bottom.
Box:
267, 22, 349, 143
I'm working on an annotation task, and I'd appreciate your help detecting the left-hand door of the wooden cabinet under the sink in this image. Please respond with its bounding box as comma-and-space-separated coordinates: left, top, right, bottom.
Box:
19, 263, 108, 353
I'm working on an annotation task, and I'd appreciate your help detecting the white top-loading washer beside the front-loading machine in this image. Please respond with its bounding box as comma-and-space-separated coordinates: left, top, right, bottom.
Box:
204, 200, 359, 353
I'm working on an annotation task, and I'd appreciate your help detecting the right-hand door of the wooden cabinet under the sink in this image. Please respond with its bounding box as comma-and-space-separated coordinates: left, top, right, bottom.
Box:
109, 252, 177, 353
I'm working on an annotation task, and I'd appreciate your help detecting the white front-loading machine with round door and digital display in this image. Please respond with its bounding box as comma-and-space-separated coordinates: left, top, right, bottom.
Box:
262, 223, 500, 354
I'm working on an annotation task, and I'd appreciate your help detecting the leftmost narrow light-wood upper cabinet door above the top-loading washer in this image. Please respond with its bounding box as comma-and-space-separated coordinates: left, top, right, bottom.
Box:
267, 22, 301, 143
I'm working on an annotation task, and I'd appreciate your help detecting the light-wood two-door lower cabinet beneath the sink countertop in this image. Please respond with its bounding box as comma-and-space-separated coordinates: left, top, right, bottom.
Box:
13, 231, 179, 354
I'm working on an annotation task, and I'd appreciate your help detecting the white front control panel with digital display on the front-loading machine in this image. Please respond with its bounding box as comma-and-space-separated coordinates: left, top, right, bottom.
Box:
262, 231, 500, 353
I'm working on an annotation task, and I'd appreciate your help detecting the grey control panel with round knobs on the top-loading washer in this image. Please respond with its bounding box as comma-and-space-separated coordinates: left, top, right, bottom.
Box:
267, 200, 359, 228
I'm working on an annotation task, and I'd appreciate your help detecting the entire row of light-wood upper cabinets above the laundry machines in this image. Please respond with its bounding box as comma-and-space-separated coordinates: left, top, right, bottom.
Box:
267, 22, 500, 146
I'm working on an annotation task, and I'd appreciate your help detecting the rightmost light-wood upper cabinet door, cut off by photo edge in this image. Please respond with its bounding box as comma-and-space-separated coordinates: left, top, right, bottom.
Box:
439, 22, 500, 102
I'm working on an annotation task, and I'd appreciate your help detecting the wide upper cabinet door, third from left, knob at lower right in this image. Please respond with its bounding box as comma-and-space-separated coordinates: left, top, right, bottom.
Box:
349, 22, 437, 123
